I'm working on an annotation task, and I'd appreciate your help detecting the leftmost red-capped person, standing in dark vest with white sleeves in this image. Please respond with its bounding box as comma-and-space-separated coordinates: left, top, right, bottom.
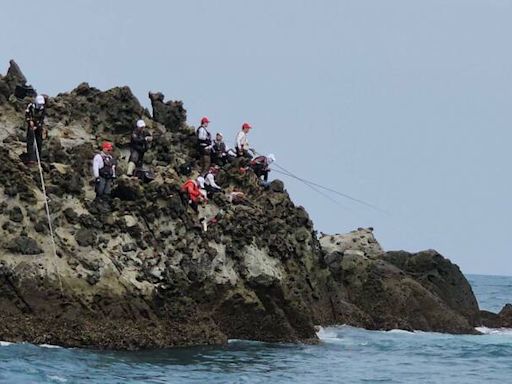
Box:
92, 141, 116, 199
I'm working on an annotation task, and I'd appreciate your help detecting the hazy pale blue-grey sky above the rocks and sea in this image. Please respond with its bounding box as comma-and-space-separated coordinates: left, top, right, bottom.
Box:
0, 0, 512, 275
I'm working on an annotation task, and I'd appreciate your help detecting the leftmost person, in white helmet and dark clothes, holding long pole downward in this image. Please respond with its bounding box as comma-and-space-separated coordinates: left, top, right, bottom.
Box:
25, 95, 46, 165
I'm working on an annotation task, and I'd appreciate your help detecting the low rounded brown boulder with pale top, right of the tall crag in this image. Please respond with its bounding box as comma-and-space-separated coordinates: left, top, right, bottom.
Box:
320, 229, 479, 333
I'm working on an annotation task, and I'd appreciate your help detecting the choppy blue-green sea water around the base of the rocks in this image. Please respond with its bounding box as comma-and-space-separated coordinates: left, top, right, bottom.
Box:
0, 275, 512, 384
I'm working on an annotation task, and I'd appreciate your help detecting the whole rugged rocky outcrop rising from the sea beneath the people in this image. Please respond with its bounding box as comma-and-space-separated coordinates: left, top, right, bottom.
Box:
0, 59, 504, 349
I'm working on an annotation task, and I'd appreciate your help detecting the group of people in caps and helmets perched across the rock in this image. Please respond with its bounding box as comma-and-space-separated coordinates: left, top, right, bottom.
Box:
21, 95, 275, 228
